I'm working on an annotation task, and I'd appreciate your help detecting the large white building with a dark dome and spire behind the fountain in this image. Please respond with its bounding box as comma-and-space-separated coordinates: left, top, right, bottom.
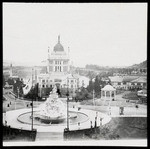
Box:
35, 36, 89, 96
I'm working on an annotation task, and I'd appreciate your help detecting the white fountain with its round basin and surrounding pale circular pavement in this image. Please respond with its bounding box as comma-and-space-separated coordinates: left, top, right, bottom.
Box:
6, 86, 111, 137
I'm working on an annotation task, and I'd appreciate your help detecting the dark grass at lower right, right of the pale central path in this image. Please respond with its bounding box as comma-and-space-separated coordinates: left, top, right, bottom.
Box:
64, 117, 147, 140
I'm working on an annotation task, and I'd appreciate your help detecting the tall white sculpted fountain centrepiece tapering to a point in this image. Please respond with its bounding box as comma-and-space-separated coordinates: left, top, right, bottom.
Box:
33, 86, 67, 124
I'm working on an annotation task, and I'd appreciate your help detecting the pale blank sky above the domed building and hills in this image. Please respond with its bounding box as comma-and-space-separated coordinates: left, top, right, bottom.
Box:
3, 3, 147, 67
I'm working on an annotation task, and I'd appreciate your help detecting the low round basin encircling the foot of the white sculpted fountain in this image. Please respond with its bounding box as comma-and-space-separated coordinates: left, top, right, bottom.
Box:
17, 111, 89, 126
